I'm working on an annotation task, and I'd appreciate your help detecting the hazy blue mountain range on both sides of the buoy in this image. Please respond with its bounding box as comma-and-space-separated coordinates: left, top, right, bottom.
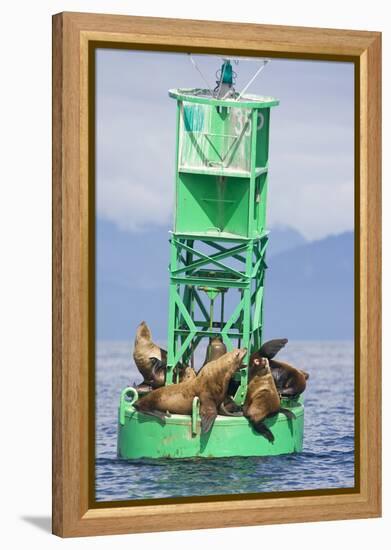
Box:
96, 220, 354, 340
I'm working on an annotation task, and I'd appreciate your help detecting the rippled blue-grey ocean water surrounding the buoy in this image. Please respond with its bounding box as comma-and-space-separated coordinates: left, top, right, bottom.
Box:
96, 341, 354, 501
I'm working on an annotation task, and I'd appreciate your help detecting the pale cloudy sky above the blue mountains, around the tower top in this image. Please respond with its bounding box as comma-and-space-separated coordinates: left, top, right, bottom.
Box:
96, 49, 354, 240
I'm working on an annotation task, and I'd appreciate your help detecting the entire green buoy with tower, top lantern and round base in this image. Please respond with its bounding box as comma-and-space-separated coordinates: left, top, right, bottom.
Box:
118, 58, 304, 459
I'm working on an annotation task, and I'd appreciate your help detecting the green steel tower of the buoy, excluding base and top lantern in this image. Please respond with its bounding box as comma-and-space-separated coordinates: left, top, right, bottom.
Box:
166, 89, 278, 388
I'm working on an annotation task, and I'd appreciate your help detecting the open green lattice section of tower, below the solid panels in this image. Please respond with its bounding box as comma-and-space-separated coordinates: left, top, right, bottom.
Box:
167, 232, 267, 404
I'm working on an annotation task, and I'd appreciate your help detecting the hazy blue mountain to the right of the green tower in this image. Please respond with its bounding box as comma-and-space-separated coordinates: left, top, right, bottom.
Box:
264, 232, 354, 340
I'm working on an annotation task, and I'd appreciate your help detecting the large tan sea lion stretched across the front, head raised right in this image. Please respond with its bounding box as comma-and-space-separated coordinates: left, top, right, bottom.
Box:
134, 349, 247, 433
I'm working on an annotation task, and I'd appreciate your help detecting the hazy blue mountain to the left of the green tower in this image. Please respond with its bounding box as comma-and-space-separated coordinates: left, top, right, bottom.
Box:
96, 220, 169, 340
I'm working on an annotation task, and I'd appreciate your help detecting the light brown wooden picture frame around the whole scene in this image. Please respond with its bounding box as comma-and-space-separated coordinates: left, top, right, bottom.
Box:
53, 13, 381, 537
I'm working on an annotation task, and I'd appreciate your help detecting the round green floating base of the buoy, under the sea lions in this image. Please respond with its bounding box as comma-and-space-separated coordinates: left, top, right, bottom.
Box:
118, 388, 304, 459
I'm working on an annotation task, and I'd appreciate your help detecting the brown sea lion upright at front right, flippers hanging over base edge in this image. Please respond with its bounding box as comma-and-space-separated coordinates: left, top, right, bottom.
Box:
243, 357, 295, 443
